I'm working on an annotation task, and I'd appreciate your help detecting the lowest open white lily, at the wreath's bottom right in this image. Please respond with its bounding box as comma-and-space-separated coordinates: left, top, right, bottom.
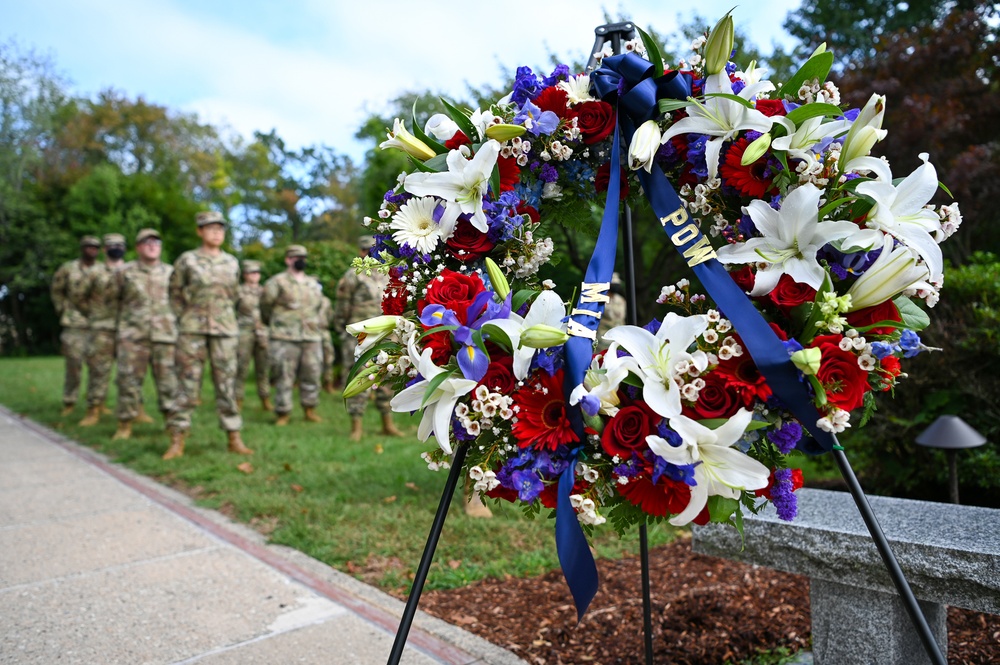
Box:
646, 409, 771, 526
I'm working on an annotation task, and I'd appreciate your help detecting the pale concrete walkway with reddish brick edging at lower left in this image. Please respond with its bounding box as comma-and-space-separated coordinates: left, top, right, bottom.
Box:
0, 407, 524, 665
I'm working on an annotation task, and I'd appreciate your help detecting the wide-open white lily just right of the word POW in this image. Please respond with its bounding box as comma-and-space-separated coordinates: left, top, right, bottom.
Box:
718, 183, 858, 296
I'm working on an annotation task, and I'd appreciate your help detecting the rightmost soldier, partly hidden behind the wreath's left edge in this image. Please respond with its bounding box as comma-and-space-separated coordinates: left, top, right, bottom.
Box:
333, 236, 402, 441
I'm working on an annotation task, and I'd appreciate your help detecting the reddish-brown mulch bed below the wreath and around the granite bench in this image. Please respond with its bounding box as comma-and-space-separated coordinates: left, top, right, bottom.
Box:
420, 538, 1000, 665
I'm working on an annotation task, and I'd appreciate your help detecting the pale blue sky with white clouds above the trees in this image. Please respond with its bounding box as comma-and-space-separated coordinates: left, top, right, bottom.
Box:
0, 0, 800, 161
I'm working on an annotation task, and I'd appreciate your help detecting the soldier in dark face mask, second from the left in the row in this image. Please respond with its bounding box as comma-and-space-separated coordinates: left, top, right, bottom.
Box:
80, 233, 125, 427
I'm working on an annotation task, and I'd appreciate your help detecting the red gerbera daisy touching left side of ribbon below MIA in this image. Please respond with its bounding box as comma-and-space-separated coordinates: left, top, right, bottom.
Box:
512, 370, 576, 450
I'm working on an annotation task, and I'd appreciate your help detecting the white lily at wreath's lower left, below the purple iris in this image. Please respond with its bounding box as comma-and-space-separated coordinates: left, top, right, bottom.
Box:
389, 342, 476, 455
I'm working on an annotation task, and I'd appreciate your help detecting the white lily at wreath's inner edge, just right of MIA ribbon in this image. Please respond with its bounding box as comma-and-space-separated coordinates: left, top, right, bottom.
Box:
604, 312, 708, 418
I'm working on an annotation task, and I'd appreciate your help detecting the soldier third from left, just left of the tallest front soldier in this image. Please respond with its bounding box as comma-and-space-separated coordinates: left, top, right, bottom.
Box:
111, 229, 177, 439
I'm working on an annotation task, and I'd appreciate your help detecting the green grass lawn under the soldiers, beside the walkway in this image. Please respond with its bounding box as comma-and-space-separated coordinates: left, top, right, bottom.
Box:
0, 357, 676, 593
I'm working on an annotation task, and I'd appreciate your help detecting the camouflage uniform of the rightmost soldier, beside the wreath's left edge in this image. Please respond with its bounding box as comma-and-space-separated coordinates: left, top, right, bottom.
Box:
333, 268, 392, 418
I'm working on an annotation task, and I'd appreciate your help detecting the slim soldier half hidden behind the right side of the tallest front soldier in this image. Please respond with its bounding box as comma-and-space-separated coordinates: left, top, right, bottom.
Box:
236, 260, 272, 411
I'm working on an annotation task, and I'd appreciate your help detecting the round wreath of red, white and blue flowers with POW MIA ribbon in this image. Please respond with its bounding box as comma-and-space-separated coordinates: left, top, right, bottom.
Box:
345, 15, 961, 607
